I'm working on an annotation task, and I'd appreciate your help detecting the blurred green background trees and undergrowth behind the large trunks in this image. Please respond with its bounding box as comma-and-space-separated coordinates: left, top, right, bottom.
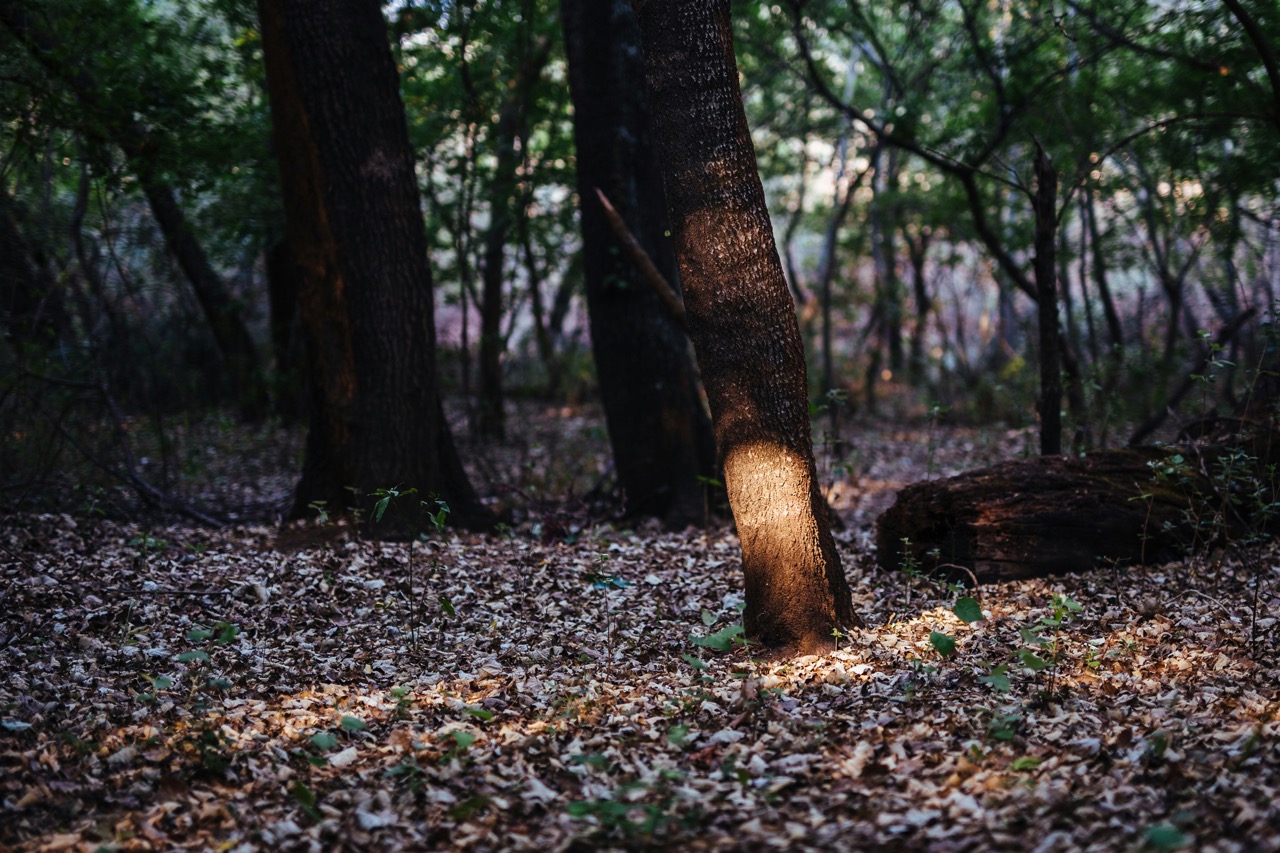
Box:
0, 0, 1280, 512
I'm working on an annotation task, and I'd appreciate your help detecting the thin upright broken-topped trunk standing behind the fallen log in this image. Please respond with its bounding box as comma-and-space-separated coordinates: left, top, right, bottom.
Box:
1036, 146, 1062, 456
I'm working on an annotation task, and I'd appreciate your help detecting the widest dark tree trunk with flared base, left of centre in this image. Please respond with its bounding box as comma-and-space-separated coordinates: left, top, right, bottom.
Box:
259, 0, 490, 533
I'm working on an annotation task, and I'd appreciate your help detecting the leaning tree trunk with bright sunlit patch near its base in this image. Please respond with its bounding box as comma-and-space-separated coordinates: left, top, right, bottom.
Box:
636, 0, 854, 648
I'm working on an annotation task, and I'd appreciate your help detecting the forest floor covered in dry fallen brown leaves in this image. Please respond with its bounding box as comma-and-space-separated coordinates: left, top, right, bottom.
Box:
0, 409, 1280, 850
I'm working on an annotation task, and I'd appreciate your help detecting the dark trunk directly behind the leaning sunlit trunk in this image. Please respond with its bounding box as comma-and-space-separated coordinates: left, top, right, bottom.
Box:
561, 0, 717, 526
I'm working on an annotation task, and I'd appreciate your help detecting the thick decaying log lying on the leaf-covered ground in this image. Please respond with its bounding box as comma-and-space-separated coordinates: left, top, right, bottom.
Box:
876, 429, 1280, 583
